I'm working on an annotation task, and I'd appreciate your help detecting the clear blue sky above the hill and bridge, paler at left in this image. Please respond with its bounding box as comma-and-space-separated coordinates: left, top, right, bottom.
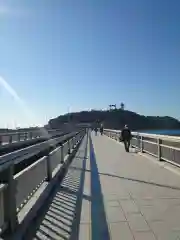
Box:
0, 0, 180, 127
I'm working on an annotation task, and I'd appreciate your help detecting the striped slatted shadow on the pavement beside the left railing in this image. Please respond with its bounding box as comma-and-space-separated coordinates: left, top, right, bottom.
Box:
23, 137, 87, 240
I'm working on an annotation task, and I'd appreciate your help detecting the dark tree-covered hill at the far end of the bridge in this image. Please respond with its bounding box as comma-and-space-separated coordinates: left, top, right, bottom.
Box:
48, 109, 180, 130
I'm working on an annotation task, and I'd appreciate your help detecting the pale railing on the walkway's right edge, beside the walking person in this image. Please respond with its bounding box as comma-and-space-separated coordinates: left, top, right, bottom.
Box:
104, 129, 180, 167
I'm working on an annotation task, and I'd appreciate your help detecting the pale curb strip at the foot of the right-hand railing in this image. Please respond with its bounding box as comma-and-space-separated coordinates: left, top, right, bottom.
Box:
107, 136, 180, 176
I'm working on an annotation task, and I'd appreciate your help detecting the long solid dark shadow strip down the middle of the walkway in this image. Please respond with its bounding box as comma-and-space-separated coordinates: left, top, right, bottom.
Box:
89, 137, 110, 240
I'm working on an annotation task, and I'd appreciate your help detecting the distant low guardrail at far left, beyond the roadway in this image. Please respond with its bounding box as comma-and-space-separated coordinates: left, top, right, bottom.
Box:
0, 129, 63, 145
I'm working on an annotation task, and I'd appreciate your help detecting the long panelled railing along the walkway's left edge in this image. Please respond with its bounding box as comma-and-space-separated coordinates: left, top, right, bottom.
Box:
0, 129, 86, 235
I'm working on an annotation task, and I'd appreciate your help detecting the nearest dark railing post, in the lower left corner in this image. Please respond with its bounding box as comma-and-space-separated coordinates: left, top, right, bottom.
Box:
0, 164, 18, 233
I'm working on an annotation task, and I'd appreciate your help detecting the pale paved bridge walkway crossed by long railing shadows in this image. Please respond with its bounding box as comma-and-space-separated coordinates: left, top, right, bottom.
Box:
25, 134, 180, 240
